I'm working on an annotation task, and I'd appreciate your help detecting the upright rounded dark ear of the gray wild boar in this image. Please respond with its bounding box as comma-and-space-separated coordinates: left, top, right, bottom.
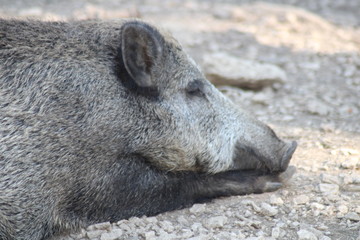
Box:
121, 21, 164, 87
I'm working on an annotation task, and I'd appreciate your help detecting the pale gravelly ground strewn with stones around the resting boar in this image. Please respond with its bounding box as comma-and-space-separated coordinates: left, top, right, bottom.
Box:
0, 0, 360, 240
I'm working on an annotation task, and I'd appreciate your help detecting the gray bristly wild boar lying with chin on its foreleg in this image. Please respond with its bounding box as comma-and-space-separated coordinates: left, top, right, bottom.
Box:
0, 19, 296, 240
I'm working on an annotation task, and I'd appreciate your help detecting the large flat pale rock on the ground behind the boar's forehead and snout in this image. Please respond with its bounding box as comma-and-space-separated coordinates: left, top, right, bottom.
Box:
203, 52, 286, 90
